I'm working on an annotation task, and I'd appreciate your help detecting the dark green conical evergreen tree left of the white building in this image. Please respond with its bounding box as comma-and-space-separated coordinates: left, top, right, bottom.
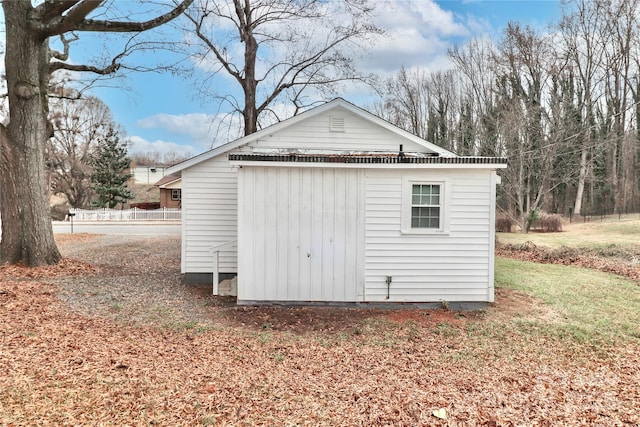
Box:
91, 127, 133, 209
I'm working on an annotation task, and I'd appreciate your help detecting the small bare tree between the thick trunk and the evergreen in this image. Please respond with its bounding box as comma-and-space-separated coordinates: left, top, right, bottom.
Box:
46, 96, 122, 208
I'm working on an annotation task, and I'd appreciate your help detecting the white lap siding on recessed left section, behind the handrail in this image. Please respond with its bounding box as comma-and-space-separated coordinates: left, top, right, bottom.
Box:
182, 155, 238, 273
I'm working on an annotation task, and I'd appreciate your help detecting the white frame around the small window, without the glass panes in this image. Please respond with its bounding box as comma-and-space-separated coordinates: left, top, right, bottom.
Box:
400, 175, 451, 235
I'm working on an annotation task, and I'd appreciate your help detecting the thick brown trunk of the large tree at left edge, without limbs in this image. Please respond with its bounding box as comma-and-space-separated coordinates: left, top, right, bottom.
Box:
0, 1, 61, 266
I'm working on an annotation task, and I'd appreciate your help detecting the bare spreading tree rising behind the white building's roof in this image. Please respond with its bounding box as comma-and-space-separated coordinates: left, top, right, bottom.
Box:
181, 0, 380, 135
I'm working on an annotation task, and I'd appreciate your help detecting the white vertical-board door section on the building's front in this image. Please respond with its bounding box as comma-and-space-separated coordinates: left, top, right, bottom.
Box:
238, 166, 364, 302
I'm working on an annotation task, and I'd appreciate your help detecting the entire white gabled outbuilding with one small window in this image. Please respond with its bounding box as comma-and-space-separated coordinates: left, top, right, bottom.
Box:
168, 99, 506, 304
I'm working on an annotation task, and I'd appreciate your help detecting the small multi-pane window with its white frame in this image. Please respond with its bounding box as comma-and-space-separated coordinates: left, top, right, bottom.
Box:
401, 176, 450, 234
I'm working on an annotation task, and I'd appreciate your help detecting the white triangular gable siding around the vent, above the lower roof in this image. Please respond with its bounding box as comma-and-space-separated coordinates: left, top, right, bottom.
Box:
251, 108, 428, 152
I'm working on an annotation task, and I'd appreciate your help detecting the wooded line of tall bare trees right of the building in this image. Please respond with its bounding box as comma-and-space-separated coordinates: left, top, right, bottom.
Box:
376, 0, 640, 231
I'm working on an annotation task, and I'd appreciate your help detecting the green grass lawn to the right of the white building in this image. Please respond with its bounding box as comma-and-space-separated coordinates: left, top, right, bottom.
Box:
496, 219, 640, 342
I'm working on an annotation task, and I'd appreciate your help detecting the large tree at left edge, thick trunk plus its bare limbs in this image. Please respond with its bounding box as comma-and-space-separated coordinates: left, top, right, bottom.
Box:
0, 0, 193, 266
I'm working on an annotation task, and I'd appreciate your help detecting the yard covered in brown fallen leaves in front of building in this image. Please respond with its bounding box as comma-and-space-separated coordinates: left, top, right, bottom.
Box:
0, 235, 640, 426
